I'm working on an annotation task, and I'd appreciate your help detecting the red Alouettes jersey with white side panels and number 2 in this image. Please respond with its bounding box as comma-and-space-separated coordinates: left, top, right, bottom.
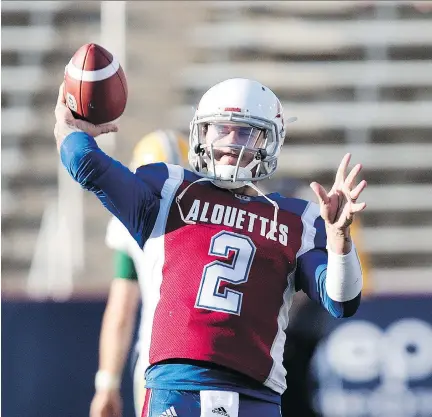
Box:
137, 165, 319, 393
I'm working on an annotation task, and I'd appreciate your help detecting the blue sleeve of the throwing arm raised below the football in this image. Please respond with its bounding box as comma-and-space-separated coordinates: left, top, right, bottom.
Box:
60, 132, 167, 247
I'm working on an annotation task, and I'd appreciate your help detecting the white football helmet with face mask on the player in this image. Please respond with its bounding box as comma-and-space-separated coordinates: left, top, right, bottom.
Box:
188, 78, 296, 189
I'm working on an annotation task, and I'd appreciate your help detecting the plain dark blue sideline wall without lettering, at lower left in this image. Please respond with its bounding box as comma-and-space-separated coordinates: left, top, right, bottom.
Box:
1, 300, 134, 417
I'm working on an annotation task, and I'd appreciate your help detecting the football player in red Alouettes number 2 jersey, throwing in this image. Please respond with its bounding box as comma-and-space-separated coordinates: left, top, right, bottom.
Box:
55, 78, 366, 417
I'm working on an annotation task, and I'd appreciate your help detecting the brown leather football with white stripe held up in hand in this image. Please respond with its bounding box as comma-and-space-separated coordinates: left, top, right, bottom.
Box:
64, 43, 128, 124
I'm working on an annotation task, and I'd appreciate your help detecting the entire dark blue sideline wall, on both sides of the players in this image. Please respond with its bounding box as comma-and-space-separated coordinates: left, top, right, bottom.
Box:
1, 297, 432, 417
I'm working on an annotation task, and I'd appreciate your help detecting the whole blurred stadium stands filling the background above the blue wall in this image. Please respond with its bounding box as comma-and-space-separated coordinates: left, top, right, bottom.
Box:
1, 1, 432, 293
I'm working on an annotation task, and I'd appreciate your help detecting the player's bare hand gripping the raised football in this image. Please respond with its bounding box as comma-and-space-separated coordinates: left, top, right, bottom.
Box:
54, 83, 118, 149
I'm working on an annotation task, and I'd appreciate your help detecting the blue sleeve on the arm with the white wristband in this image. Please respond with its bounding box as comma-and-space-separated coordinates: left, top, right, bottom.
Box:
295, 217, 361, 318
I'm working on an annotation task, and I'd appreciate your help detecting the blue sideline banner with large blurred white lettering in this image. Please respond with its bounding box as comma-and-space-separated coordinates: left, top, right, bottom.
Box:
313, 296, 432, 417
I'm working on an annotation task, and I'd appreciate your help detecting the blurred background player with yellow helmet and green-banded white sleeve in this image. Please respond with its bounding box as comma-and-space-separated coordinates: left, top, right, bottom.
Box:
90, 130, 189, 417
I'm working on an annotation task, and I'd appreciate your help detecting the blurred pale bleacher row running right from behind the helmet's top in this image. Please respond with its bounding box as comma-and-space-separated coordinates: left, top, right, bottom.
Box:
176, 60, 432, 93
